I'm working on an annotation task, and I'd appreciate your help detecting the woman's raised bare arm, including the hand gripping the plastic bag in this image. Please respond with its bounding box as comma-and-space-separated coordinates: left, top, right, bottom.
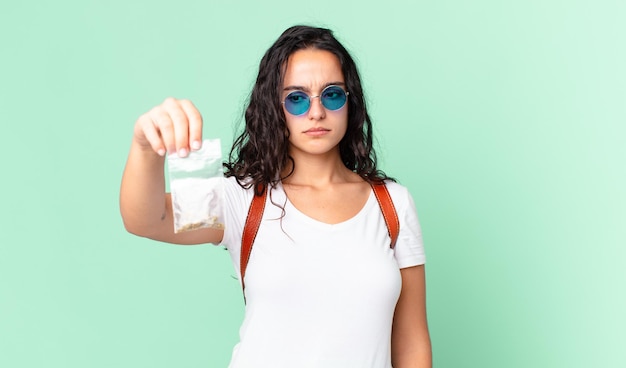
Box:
120, 98, 224, 244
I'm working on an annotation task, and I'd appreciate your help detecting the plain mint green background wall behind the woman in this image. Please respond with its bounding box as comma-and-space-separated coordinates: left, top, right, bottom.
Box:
0, 0, 626, 368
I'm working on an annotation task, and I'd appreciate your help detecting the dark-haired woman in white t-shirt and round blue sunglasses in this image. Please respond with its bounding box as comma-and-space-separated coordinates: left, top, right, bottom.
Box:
120, 26, 431, 368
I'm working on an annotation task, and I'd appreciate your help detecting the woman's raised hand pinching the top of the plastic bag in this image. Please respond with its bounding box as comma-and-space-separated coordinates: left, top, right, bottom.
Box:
134, 97, 202, 157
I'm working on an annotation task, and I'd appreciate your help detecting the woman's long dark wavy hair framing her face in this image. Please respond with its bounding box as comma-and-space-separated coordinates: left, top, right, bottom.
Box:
224, 26, 391, 194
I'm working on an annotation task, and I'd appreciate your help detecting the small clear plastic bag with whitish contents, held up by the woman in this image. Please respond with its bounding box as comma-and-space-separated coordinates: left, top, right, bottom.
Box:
167, 139, 224, 233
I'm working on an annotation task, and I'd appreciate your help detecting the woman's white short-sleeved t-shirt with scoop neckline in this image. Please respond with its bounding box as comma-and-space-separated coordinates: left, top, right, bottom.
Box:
216, 177, 425, 368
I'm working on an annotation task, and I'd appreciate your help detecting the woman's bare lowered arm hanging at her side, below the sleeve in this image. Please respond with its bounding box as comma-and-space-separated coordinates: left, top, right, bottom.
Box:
391, 265, 432, 368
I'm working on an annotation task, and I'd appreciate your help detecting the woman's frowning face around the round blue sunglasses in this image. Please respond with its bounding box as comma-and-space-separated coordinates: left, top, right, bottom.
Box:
281, 49, 348, 158
